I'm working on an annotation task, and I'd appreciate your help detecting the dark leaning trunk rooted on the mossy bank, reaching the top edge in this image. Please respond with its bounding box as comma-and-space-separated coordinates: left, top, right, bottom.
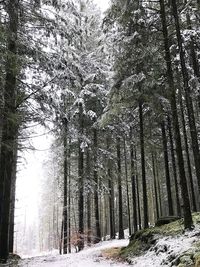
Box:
160, 0, 193, 228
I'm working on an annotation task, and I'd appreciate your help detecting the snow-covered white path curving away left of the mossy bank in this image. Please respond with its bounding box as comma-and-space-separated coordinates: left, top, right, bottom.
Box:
19, 240, 128, 267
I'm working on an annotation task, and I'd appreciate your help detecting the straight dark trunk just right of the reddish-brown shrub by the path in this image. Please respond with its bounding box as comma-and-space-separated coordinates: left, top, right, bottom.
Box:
93, 128, 101, 243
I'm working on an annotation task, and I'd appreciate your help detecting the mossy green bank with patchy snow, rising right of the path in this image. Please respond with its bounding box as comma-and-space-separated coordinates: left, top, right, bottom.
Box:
120, 213, 200, 267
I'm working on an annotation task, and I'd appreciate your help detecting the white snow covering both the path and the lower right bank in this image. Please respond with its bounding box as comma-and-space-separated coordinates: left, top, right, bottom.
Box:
4, 227, 200, 267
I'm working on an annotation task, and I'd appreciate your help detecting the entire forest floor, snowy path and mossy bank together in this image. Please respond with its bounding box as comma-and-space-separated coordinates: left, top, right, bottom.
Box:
3, 216, 200, 267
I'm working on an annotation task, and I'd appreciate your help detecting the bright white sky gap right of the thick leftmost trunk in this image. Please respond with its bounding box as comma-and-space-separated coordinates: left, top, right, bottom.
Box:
16, 127, 52, 224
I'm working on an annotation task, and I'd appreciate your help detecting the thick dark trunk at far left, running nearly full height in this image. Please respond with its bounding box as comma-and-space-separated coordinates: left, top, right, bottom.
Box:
0, 0, 19, 261
